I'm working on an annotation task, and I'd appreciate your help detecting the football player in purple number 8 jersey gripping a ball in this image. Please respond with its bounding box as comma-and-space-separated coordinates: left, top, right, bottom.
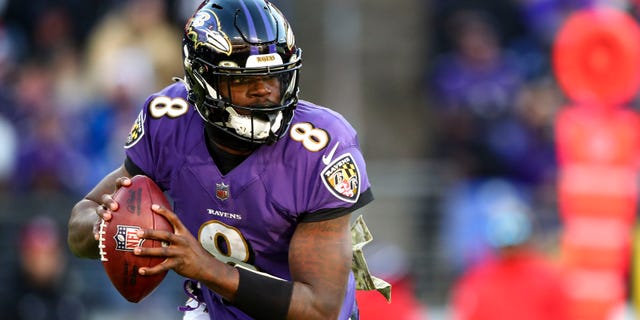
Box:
68, 0, 373, 320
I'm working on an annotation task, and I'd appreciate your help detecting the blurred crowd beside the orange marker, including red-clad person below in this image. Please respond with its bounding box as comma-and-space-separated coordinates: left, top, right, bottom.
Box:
424, 0, 638, 319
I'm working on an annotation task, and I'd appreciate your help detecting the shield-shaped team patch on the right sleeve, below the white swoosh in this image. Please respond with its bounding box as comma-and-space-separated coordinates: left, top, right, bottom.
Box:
320, 153, 360, 203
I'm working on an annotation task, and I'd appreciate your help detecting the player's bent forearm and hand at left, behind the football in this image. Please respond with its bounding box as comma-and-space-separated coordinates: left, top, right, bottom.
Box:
67, 166, 131, 259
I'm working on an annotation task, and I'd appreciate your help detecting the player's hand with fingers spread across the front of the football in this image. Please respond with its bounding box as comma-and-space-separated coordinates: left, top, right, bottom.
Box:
134, 205, 222, 279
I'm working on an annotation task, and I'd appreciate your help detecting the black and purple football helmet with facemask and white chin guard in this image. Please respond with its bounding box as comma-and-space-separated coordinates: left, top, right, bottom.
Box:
183, 0, 302, 150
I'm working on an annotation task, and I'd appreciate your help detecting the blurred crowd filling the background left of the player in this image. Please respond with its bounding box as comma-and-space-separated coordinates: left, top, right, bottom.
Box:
0, 0, 199, 320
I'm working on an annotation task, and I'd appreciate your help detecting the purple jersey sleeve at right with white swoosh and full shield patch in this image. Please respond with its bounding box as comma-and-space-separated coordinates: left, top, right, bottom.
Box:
282, 104, 373, 222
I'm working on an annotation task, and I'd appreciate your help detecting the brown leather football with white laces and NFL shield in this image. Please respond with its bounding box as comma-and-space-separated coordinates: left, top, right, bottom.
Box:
98, 175, 173, 303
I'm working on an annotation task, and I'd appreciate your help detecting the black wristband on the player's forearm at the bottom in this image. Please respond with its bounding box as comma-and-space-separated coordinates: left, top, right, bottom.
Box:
233, 266, 293, 319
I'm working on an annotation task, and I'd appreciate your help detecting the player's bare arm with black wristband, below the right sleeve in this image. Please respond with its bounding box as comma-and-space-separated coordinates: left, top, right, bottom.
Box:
210, 211, 351, 319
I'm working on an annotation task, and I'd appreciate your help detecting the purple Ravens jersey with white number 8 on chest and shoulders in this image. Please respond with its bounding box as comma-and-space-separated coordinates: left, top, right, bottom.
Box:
125, 82, 372, 320
